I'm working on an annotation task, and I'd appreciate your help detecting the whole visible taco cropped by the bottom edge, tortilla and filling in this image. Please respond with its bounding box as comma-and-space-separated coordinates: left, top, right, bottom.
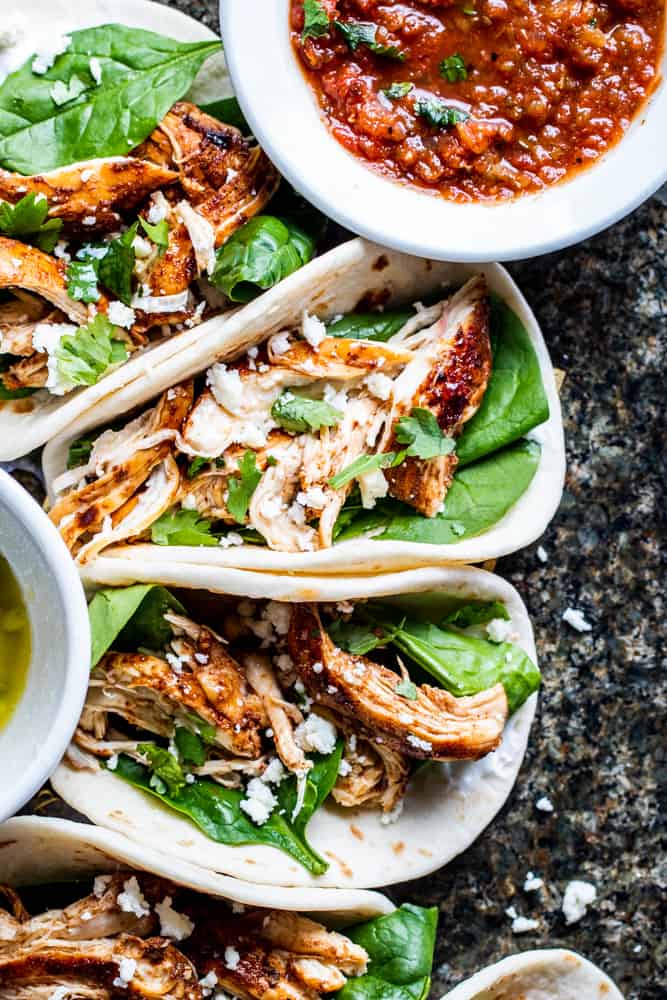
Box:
0, 818, 437, 1000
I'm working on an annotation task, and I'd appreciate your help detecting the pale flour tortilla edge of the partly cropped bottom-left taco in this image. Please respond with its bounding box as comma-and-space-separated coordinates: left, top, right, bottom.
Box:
0, 816, 394, 923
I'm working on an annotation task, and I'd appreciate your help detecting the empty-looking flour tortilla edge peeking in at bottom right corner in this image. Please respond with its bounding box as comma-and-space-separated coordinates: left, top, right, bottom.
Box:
442, 948, 623, 1000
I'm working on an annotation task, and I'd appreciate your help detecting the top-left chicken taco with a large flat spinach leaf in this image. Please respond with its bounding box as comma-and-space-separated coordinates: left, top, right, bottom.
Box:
0, 3, 324, 460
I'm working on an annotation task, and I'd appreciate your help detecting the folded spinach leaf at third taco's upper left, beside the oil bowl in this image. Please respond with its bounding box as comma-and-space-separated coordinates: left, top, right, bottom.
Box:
88, 583, 185, 667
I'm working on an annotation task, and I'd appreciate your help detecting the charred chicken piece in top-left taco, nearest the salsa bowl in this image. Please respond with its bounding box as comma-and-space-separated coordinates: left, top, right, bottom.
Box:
137, 101, 280, 328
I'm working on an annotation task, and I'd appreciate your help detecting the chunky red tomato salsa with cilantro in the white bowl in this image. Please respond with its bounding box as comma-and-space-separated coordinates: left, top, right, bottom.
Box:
291, 0, 664, 201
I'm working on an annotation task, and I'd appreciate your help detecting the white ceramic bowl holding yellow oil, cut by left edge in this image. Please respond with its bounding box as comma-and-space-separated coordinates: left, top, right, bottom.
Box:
0, 470, 90, 821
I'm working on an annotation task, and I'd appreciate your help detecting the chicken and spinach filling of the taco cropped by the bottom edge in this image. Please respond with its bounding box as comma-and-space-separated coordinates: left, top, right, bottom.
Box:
0, 871, 437, 1000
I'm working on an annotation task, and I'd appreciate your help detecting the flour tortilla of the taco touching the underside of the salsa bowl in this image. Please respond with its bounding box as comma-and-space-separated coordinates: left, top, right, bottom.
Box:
43, 239, 565, 576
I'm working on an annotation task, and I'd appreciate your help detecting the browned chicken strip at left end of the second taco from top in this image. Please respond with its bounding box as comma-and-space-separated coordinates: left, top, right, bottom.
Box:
50, 382, 193, 561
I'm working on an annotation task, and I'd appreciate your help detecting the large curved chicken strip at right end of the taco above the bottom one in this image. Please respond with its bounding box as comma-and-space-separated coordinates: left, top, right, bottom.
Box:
288, 604, 508, 760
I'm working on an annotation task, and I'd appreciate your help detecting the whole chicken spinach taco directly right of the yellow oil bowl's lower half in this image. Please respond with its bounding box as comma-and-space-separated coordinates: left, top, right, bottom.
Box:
52, 569, 540, 887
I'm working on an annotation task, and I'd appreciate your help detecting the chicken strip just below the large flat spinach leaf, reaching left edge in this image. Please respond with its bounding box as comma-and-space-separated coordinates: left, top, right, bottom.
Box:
0, 156, 178, 236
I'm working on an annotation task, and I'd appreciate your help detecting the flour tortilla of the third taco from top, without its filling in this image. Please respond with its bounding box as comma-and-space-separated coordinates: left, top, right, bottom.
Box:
52, 568, 537, 889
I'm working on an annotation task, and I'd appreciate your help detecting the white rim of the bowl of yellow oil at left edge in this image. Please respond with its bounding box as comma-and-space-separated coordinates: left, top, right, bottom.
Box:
0, 469, 90, 821
